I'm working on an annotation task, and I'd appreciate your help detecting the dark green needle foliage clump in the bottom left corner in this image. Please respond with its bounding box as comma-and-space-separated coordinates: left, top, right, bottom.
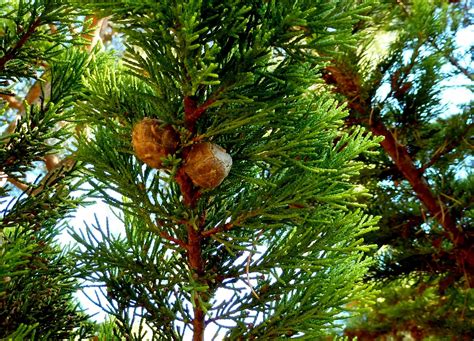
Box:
0, 219, 92, 339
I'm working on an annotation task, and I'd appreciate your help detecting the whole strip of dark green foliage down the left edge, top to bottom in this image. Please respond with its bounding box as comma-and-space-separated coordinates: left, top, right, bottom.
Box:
0, 1, 93, 334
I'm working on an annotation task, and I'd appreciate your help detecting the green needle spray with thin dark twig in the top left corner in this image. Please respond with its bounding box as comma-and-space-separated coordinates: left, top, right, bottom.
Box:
0, 0, 85, 92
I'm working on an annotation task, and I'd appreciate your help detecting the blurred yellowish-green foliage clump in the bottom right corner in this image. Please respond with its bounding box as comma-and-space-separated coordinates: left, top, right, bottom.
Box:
346, 278, 474, 340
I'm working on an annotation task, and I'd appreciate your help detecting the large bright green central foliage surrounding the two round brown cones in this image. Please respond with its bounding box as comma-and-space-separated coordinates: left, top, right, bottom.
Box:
72, 1, 378, 340
